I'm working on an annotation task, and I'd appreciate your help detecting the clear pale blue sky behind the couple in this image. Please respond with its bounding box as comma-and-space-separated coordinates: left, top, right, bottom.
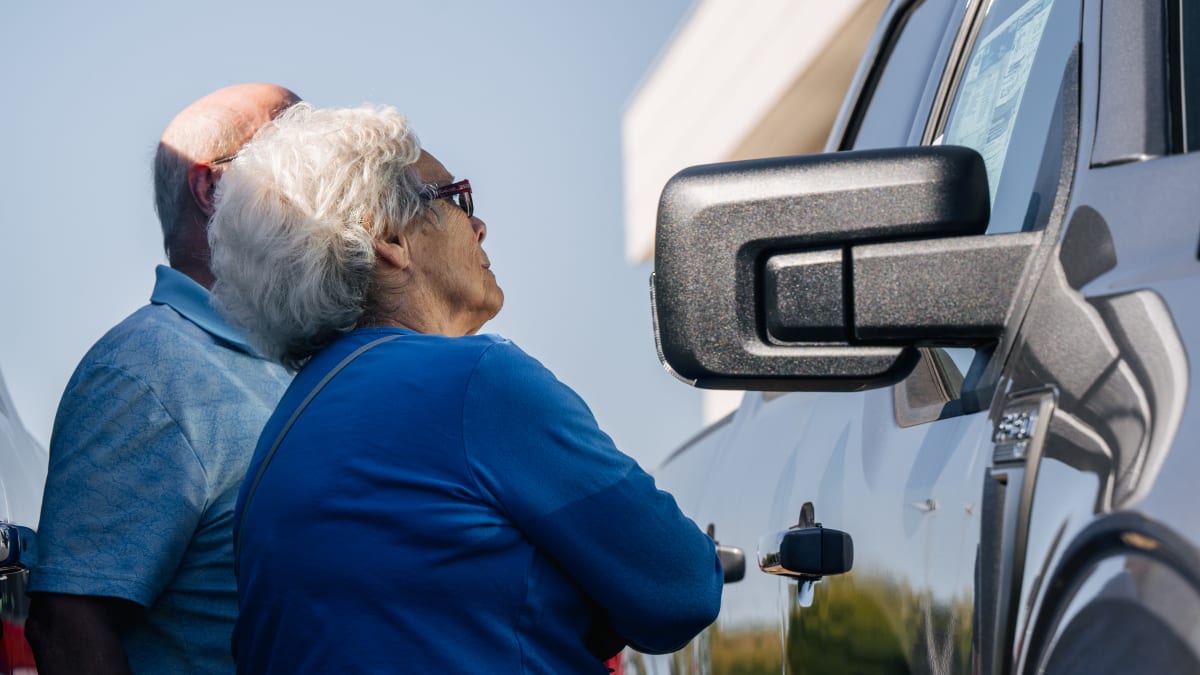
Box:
0, 0, 701, 468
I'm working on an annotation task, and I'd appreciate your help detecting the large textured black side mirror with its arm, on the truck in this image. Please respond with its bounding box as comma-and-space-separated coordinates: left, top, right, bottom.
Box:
650, 145, 1036, 392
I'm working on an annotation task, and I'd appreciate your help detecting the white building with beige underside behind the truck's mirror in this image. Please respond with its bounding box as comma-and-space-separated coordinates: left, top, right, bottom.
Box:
622, 0, 887, 423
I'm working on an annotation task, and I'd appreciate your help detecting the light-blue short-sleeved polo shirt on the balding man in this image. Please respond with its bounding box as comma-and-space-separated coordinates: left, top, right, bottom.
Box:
30, 267, 290, 674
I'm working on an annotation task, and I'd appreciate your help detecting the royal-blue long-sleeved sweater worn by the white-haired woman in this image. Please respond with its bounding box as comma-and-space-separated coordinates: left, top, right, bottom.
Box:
234, 329, 721, 674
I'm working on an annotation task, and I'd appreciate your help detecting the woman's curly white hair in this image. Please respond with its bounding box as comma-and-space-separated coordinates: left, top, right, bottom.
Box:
209, 103, 432, 371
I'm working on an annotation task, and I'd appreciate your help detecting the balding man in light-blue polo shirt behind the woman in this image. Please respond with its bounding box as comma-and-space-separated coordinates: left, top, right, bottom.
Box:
26, 84, 302, 675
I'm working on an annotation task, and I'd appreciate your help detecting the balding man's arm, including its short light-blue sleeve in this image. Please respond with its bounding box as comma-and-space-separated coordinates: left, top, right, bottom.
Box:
26, 365, 203, 675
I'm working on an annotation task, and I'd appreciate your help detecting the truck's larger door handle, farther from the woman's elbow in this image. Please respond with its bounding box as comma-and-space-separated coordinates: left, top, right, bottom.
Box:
758, 522, 854, 578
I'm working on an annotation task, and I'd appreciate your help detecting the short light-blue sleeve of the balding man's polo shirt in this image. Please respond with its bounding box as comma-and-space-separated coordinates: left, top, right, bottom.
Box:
30, 365, 206, 607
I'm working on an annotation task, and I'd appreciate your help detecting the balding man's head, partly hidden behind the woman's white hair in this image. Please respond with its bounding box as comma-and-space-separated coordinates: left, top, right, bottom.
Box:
154, 83, 300, 287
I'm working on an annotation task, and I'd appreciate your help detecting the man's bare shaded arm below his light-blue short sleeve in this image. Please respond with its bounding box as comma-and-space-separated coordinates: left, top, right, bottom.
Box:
25, 593, 145, 675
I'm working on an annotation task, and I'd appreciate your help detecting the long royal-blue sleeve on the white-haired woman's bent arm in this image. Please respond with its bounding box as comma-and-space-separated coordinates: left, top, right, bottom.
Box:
463, 342, 722, 653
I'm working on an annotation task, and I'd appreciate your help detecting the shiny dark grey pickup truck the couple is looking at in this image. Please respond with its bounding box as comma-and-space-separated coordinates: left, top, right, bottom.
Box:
625, 0, 1200, 674
